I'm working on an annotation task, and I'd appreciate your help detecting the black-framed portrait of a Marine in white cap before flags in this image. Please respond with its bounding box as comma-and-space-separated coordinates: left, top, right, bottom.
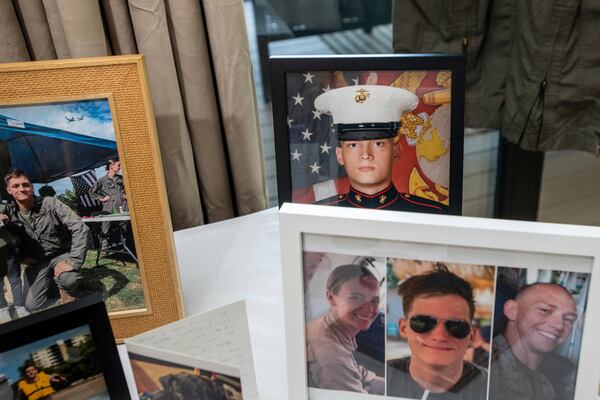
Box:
270, 54, 465, 215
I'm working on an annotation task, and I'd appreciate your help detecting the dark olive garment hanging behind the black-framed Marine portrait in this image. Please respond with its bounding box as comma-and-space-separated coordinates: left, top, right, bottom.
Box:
393, 0, 600, 155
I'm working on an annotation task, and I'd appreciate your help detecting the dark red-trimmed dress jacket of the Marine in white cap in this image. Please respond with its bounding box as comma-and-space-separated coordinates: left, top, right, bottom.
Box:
316, 184, 448, 213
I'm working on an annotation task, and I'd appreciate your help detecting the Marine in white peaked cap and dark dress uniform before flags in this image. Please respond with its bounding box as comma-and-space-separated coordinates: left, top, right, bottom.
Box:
315, 85, 448, 213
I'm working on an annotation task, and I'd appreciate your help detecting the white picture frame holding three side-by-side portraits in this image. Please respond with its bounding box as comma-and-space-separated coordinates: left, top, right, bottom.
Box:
279, 203, 600, 400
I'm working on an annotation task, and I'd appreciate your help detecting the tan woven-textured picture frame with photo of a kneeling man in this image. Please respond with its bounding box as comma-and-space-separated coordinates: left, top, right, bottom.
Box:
0, 55, 183, 339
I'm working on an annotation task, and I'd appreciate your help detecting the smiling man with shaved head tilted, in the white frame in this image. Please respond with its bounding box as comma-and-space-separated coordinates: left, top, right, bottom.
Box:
489, 283, 577, 400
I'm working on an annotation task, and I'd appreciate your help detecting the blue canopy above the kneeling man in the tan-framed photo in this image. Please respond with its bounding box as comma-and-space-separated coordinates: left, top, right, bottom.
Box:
0, 115, 117, 183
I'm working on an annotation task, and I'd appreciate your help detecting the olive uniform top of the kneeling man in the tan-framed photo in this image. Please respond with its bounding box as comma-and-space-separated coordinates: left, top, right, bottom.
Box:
0, 197, 89, 268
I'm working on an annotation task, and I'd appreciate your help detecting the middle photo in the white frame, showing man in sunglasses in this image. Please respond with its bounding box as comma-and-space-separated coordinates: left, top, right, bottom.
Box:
386, 260, 494, 400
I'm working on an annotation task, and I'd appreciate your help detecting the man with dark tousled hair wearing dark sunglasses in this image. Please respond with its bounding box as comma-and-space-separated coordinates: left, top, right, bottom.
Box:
387, 266, 487, 400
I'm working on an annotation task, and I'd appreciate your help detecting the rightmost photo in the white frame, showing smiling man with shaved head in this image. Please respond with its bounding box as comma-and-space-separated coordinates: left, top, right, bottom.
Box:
489, 267, 589, 400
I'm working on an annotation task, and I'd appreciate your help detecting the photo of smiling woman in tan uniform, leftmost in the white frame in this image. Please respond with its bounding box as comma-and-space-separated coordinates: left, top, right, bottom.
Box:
305, 253, 385, 394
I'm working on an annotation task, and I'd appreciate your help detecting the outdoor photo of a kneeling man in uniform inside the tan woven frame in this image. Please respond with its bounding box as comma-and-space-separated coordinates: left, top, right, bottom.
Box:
0, 100, 145, 323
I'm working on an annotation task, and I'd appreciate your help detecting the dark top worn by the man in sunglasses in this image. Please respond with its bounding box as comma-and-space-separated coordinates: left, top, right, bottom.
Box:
387, 357, 490, 400
